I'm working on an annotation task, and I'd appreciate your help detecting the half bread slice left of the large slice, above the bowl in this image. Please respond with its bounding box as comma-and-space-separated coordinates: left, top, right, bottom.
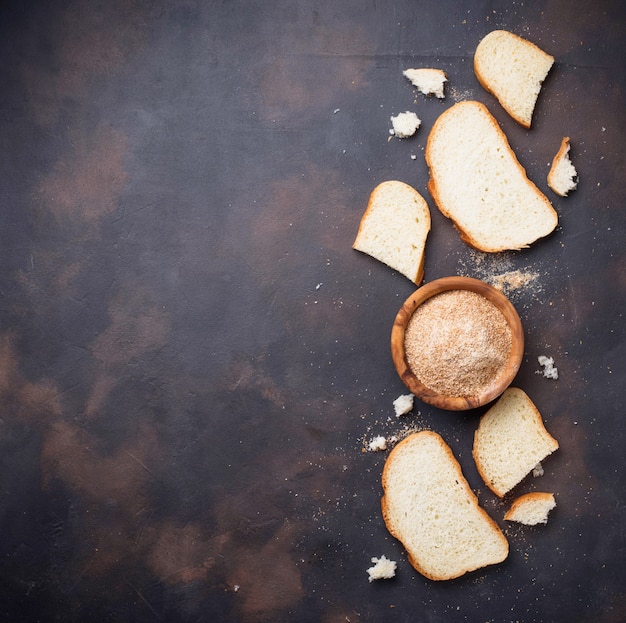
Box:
352, 180, 430, 285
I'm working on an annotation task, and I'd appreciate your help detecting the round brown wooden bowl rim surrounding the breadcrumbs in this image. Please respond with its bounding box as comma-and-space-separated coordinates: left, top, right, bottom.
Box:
391, 277, 524, 411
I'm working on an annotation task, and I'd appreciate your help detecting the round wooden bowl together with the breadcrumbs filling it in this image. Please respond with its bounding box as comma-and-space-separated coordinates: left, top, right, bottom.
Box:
391, 276, 524, 411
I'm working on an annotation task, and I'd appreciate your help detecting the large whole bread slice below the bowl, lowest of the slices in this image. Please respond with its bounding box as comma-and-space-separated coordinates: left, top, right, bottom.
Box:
381, 431, 509, 580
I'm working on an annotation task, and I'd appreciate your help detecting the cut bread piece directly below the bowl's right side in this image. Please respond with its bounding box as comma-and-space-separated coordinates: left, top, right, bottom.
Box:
472, 387, 559, 497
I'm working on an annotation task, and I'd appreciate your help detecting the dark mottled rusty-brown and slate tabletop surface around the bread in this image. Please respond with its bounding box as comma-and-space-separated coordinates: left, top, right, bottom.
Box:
0, 0, 626, 623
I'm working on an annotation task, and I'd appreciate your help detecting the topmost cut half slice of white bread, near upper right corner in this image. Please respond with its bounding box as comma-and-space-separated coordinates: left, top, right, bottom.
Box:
474, 30, 554, 128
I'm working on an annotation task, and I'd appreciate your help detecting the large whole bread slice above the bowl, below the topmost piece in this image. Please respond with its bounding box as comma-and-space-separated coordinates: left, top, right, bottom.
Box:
426, 101, 558, 252
